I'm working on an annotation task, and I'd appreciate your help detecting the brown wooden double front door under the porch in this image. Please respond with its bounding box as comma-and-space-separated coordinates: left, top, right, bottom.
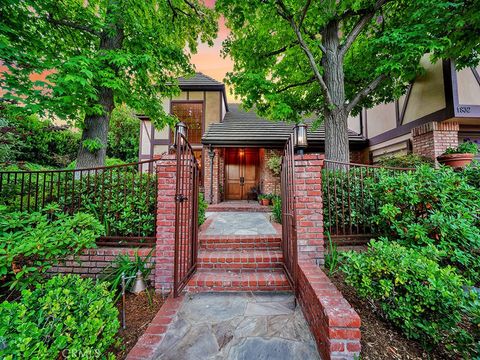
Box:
225, 148, 259, 200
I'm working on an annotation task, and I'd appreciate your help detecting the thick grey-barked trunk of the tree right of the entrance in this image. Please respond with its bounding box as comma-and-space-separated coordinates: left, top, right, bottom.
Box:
322, 22, 350, 163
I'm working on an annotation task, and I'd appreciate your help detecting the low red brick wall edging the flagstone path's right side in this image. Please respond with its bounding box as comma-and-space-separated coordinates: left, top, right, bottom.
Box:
298, 261, 361, 360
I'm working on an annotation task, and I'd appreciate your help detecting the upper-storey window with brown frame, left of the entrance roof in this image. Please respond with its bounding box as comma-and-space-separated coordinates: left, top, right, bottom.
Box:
171, 101, 203, 145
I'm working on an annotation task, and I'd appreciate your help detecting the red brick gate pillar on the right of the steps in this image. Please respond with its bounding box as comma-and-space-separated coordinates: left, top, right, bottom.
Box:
294, 154, 324, 265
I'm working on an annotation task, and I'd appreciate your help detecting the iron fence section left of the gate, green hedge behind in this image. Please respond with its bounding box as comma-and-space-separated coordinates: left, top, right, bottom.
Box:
0, 159, 157, 246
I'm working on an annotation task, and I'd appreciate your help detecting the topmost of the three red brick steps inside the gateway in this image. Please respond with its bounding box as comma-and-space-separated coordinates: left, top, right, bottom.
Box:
199, 235, 282, 251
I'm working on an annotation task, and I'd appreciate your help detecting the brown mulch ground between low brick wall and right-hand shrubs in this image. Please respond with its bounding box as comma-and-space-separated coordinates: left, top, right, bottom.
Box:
330, 273, 448, 360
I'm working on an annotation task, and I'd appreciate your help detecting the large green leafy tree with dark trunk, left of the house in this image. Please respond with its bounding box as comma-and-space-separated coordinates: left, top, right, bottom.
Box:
0, 0, 217, 168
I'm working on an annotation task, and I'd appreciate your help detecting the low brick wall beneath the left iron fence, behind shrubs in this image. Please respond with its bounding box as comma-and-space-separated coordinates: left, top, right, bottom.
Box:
49, 247, 155, 280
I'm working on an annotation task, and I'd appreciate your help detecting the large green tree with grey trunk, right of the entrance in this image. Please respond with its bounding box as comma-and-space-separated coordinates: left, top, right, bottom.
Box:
217, 0, 479, 162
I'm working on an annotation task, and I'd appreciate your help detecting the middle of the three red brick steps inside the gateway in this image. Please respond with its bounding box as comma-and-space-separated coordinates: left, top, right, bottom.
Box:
197, 250, 283, 270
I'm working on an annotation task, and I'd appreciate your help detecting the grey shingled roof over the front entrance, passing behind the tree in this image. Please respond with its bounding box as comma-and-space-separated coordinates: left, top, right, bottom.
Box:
202, 104, 367, 148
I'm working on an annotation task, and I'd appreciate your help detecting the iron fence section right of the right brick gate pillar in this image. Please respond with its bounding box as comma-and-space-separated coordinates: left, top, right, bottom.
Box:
322, 160, 414, 245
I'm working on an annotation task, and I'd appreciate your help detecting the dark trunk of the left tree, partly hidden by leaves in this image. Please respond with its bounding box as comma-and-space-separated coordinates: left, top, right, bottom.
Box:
76, 0, 124, 169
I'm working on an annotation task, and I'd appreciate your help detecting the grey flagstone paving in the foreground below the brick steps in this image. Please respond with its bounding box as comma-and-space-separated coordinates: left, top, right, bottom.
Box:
154, 293, 320, 360
